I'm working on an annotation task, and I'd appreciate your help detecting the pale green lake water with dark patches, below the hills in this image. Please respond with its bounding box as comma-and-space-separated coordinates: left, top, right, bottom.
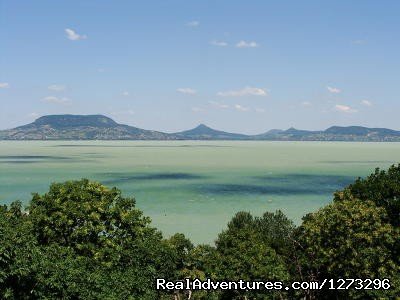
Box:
0, 141, 400, 243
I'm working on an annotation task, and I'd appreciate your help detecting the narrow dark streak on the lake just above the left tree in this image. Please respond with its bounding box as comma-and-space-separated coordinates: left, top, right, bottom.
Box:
100, 173, 204, 184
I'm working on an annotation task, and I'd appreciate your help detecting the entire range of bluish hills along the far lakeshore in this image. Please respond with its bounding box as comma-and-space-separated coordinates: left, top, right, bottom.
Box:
0, 115, 400, 142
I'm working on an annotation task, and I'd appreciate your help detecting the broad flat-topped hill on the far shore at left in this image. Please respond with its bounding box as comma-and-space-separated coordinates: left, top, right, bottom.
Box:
0, 115, 172, 140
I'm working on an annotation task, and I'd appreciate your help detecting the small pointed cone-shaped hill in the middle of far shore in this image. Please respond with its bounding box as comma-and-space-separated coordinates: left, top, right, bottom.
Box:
174, 124, 251, 140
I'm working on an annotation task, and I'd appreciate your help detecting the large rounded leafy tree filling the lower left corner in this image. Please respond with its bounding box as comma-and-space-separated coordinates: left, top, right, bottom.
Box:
0, 179, 177, 299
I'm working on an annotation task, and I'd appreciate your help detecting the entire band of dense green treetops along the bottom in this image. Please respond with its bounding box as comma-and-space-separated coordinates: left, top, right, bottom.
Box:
0, 166, 400, 299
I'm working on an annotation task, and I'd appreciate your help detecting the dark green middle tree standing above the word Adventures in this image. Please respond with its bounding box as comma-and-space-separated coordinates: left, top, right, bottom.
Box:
216, 212, 289, 299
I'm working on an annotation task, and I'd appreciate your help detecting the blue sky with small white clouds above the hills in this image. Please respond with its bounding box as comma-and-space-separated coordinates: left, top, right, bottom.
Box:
0, 0, 400, 133
